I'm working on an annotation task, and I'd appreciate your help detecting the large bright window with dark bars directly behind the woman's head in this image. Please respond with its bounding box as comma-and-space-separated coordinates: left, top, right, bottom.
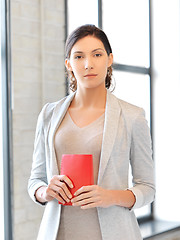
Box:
66, 0, 152, 218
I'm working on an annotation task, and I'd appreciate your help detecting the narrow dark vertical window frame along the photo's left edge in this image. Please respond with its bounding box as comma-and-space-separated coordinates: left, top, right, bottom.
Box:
1, 0, 13, 240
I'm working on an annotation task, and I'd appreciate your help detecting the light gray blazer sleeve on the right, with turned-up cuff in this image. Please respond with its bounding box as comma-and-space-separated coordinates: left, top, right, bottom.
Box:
129, 109, 155, 210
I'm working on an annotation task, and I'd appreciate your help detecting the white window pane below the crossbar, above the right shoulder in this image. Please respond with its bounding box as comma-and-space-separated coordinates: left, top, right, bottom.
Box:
113, 71, 150, 125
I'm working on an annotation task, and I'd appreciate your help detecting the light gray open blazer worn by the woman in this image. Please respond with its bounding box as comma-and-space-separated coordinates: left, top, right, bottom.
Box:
28, 91, 155, 240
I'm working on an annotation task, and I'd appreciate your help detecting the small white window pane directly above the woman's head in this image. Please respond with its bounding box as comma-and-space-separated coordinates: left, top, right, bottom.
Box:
68, 0, 98, 33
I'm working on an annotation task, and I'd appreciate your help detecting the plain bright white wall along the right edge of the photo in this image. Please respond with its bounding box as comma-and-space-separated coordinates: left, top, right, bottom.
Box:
152, 0, 180, 221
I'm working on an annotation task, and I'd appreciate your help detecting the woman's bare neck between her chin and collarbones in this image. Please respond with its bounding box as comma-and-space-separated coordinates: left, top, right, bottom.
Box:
72, 88, 107, 108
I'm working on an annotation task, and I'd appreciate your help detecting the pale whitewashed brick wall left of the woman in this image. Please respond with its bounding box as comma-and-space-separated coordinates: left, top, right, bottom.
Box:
11, 0, 65, 240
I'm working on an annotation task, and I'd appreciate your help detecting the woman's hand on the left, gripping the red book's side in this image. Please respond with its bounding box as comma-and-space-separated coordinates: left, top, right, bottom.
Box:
35, 175, 73, 204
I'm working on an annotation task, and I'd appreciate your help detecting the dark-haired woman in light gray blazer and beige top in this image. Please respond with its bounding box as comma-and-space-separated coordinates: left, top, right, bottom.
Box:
28, 25, 155, 240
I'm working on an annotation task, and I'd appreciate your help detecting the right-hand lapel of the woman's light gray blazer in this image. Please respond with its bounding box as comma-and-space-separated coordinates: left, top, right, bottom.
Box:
98, 91, 121, 185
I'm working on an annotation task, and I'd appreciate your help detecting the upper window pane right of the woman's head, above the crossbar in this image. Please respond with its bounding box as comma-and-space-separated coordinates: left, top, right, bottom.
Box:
103, 0, 149, 67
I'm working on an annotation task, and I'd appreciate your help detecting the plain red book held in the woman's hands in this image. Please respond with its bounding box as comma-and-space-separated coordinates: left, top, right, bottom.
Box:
59, 154, 94, 205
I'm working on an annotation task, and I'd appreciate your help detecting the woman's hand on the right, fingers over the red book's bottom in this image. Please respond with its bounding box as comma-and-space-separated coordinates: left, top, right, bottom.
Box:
71, 185, 113, 209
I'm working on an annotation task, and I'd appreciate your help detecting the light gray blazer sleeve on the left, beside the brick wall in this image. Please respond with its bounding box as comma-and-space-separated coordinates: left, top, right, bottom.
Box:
28, 104, 48, 205
